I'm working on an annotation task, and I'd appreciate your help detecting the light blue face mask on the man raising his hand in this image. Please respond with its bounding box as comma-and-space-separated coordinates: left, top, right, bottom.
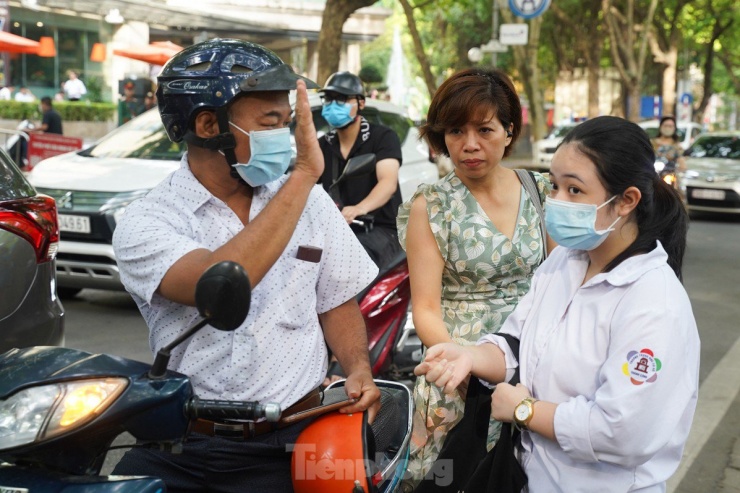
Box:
229, 122, 293, 187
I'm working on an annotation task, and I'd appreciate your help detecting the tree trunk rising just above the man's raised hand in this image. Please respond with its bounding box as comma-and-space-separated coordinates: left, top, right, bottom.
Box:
316, 0, 375, 85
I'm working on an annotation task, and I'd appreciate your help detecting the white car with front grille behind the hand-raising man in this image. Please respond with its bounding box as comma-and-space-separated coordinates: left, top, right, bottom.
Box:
28, 98, 438, 296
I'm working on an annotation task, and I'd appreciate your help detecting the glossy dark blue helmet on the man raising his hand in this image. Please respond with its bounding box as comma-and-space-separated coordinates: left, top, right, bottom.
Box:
157, 38, 319, 164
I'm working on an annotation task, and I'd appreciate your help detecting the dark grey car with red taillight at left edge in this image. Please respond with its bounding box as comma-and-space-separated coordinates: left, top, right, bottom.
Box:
0, 146, 64, 353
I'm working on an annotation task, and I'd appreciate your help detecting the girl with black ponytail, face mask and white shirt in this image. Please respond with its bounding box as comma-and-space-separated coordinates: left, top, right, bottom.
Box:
416, 117, 699, 493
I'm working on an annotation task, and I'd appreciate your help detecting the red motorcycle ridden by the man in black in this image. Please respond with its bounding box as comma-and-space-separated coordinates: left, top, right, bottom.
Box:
329, 154, 422, 380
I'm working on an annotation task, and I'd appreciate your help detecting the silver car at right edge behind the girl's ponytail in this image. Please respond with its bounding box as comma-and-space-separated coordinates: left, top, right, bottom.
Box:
678, 132, 740, 214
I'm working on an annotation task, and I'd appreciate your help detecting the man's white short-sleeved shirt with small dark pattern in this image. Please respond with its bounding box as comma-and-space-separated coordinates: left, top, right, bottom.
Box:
113, 154, 378, 409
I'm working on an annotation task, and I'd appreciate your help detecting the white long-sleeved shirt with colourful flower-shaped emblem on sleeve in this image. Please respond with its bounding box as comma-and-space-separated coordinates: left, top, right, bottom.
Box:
479, 243, 699, 493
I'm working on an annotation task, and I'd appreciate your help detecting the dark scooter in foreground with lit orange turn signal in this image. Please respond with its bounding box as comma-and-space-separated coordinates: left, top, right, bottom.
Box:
0, 262, 413, 493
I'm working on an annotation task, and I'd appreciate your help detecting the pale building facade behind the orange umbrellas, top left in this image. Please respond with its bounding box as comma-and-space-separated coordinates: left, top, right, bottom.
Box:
0, 0, 390, 101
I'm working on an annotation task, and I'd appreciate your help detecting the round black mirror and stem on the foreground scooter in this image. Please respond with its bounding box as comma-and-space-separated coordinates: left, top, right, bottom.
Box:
149, 261, 252, 379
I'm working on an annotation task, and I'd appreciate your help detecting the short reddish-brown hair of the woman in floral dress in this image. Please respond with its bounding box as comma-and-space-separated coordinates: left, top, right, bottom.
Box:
420, 68, 522, 157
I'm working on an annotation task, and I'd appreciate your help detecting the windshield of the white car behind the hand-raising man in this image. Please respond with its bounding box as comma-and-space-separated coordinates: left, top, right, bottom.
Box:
79, 108, 185, 161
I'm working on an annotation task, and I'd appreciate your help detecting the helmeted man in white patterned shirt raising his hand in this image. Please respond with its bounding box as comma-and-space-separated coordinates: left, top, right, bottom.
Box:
113, 39, 379, 492
